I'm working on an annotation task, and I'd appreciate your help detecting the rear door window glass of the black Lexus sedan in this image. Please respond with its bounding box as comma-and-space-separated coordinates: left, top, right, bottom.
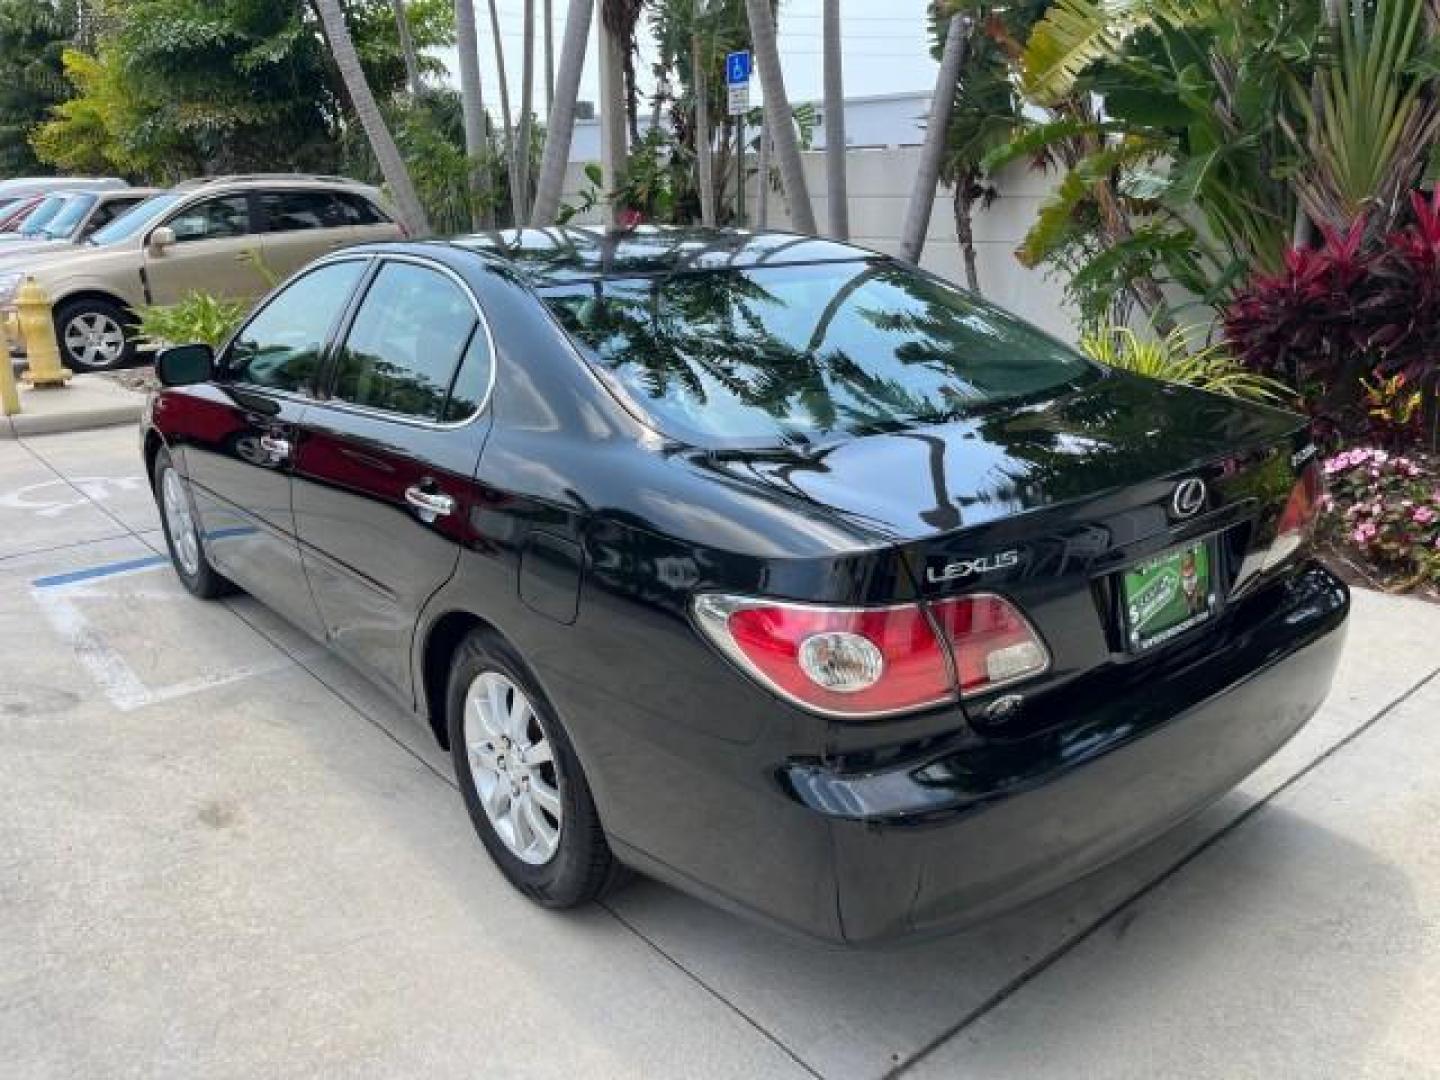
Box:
331, 262, 490, 420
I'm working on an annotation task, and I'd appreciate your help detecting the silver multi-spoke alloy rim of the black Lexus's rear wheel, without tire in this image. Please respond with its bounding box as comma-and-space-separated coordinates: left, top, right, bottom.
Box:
465, 671, 564, 865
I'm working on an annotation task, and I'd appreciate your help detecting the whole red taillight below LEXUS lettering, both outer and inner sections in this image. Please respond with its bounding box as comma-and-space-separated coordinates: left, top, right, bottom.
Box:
694, 595, 1050, 717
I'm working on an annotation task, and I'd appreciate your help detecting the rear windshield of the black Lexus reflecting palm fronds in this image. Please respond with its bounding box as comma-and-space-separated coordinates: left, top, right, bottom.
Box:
544, 259, 1094, 445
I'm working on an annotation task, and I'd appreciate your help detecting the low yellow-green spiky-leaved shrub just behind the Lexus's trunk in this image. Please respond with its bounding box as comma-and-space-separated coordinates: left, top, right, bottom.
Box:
1080, 325, 1293, 405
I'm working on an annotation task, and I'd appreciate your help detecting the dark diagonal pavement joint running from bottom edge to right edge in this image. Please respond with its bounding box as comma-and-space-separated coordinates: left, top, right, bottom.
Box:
881, 668, 1440, 1080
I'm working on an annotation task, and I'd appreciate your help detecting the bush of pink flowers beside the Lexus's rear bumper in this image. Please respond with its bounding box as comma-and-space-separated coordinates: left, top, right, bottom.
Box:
1323, 446, 1440, 589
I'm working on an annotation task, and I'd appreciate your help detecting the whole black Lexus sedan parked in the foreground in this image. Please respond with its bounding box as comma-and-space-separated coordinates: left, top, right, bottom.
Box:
144, 229, 1349, 942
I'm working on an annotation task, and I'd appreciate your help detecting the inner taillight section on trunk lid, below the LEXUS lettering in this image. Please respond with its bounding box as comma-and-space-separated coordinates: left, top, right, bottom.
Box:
930, 593, 1050, 696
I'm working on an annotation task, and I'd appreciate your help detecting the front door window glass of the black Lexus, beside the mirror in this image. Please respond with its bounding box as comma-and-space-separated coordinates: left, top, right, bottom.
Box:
223, 259, 364, 390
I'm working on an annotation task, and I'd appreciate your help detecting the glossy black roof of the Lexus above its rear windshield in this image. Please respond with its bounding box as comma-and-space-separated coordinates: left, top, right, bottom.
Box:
449, 226, 877, 288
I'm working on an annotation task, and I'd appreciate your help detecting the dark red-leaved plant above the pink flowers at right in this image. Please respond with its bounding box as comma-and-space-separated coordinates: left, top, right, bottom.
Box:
1225, 189, 1440, 444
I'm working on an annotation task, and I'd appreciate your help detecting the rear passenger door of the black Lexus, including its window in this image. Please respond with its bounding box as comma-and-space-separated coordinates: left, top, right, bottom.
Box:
294, 259, 491, 696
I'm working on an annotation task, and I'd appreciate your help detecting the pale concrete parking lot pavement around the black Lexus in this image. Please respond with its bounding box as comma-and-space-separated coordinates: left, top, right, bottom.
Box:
0, 429, 1440, 1079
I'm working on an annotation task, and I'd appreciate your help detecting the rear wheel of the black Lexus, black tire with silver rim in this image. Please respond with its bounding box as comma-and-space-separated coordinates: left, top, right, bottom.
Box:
446, 631, 621, 907
